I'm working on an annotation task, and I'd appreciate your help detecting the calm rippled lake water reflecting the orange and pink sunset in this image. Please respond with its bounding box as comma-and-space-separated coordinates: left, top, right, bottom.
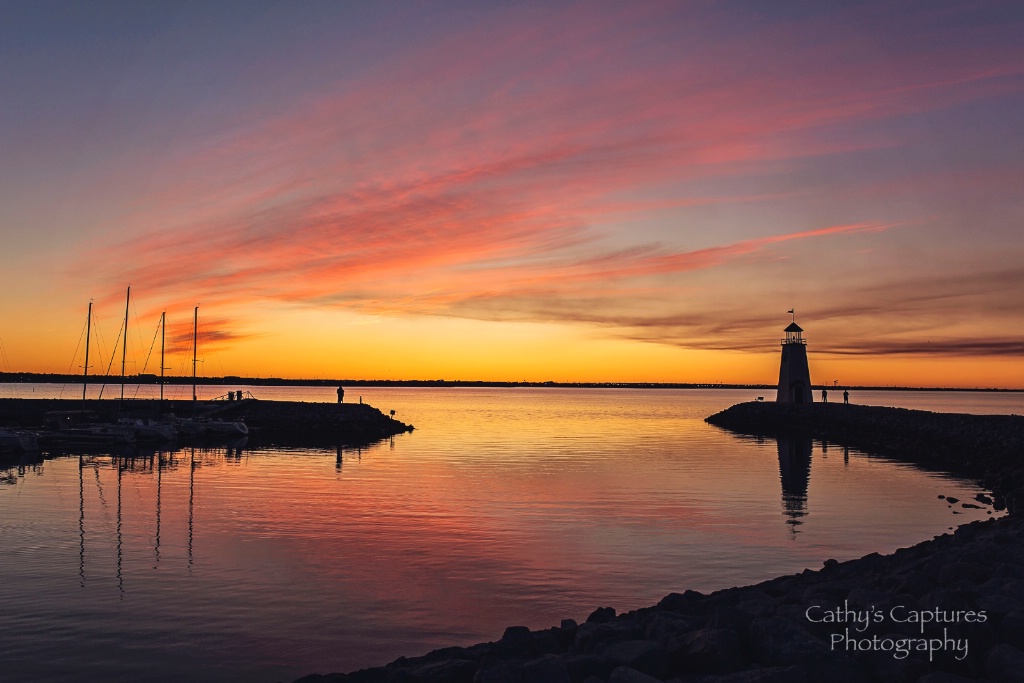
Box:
0, 385, 1007, 682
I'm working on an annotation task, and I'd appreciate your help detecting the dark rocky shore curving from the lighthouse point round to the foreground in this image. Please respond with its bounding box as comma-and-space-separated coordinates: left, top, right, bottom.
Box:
296, 403, 1024, 683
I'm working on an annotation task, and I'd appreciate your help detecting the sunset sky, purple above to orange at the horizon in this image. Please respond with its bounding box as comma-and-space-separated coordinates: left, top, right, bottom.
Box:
0, 0, 1024, 389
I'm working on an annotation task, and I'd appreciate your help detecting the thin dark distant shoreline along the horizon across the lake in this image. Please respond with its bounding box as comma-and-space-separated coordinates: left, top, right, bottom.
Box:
0, 373, 1024, 393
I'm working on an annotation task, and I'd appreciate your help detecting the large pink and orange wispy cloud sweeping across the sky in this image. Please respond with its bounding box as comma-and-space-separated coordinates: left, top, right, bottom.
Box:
68, 5, 1024, 362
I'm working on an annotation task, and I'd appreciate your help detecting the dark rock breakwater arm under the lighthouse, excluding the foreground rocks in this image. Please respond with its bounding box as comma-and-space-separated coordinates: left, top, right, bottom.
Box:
707, 401, 1024, 510
